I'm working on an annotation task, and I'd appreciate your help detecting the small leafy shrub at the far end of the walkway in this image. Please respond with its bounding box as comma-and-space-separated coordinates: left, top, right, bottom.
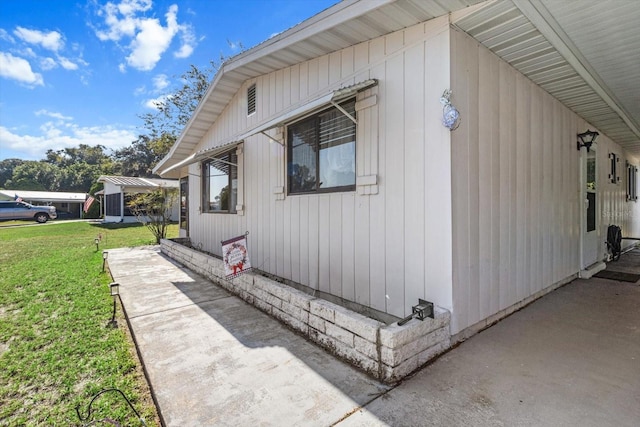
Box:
127, 187, 178, 243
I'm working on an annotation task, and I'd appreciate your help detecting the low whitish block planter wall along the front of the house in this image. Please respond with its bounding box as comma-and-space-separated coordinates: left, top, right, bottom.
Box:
160, 239, 451, 383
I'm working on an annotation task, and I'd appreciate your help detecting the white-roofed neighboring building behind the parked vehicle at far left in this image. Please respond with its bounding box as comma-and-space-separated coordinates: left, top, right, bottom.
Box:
0, 190, 87, 219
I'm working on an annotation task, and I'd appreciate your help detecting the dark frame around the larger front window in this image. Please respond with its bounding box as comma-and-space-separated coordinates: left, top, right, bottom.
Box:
285, 98, 358, 196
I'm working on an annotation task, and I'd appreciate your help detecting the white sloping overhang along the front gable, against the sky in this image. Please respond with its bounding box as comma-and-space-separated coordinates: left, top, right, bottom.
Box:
154, 0, 483, 173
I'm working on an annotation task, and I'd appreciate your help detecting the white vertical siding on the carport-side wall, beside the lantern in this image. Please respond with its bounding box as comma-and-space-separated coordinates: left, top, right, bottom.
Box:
451, 30, 639, 333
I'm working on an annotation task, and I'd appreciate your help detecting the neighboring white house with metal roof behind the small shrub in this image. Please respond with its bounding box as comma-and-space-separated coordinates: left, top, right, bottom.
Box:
98, 175, 180, 222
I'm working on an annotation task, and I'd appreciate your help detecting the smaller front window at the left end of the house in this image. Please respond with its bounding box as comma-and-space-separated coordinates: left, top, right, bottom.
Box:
202, 150, 238, 213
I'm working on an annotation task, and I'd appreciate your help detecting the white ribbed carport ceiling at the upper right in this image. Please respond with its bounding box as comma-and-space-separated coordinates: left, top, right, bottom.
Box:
453, 0, 640, 155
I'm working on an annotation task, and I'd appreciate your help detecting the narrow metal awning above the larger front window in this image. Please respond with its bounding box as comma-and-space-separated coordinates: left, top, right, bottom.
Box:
237, 79, 378, 145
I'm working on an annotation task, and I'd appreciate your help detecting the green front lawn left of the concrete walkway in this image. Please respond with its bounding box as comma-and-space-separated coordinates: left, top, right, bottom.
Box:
0, 222, 177, 426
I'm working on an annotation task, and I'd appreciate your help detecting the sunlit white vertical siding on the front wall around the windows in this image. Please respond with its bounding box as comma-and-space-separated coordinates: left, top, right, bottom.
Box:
182, 17, 452, 316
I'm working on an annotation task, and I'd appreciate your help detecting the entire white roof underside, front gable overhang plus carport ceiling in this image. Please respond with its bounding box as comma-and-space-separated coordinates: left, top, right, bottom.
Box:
154, 0, 640, 177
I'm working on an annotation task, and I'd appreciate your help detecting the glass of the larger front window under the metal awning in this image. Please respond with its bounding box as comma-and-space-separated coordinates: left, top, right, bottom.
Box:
287, 100, 356, 194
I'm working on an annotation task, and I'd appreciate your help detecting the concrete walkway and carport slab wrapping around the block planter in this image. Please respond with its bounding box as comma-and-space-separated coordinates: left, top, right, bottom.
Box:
108, 247, 640, 426
